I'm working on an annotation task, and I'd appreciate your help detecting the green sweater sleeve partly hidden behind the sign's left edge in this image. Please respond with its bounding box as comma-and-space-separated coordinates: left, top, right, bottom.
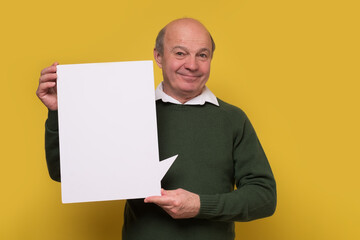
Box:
45, 110, 60, 182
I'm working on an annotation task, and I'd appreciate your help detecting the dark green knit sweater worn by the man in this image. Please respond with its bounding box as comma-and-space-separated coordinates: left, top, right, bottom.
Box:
45, 99, 276, 240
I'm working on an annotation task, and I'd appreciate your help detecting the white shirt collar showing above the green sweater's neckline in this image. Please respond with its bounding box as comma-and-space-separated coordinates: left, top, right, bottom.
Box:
155, 82, 219, 106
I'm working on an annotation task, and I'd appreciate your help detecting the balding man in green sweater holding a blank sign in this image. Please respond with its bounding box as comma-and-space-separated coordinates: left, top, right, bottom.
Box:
37, 18, 276, 240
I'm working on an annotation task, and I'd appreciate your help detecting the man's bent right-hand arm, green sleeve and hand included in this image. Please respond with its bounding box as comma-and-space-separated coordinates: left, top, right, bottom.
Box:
145, 113, 276, 221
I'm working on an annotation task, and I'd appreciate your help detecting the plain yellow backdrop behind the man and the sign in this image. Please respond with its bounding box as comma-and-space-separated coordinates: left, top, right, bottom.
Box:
0, 0, 360, 240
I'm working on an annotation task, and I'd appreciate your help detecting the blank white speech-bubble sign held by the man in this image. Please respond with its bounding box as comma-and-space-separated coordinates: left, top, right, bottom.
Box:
57, 61, 176, 203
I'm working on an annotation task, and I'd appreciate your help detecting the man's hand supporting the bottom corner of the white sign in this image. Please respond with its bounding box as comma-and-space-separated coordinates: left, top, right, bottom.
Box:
144, 188, 200, 219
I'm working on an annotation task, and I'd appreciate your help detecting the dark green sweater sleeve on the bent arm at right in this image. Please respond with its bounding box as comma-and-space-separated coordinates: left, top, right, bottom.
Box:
197, 114, 276, 221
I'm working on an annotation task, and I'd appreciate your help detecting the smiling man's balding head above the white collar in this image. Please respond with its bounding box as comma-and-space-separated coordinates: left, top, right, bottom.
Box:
154, 18, 215, 103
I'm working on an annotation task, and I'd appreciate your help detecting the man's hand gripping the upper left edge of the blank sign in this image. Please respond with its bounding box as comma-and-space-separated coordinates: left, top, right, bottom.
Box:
36, 62, 59, 110
